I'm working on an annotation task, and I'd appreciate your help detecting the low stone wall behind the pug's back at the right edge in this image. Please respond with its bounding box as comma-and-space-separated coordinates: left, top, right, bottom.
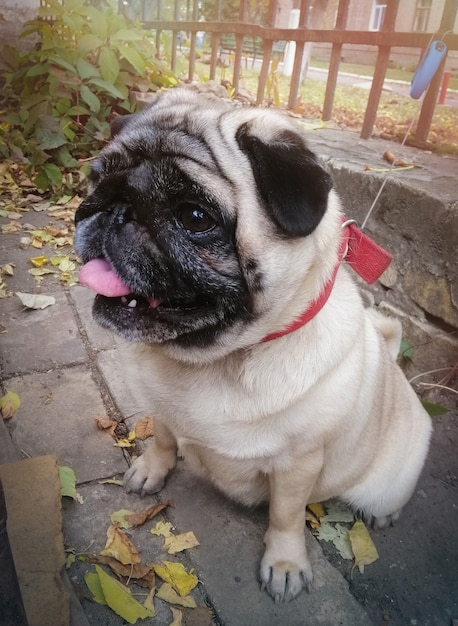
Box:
310, 130, 458, 378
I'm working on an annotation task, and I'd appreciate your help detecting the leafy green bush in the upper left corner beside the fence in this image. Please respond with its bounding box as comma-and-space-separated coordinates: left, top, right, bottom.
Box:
0, 0, 178, 191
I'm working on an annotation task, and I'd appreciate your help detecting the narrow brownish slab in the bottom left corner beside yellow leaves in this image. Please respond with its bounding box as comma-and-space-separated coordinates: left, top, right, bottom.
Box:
0, 456, 70, 626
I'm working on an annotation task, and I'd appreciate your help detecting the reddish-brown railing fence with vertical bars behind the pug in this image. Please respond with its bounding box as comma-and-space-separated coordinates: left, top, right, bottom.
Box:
142, 0, 458, 141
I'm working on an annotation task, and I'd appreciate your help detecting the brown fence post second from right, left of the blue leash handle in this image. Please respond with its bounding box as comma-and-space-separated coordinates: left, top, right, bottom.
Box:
361, 0, 399, 139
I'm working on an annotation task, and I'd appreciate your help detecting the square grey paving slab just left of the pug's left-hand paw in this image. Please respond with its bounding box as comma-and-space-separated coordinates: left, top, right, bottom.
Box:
8, 367, 126, 483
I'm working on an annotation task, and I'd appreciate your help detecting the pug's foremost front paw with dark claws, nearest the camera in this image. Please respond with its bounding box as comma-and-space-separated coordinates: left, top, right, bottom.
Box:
260, 538, 313, 602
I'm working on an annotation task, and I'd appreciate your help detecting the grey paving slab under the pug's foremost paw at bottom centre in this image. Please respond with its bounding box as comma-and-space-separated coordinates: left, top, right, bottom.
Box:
161, 466, 372, 626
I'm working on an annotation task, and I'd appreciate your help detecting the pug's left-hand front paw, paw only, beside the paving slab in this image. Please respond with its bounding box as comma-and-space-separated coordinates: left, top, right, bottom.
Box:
124, 446, 176, 497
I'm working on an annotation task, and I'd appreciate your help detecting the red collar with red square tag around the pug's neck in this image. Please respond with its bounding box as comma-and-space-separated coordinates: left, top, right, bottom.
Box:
262, 218, 393, 343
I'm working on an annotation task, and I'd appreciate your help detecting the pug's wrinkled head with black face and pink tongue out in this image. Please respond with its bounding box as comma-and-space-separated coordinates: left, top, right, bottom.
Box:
75, 89, 338, 358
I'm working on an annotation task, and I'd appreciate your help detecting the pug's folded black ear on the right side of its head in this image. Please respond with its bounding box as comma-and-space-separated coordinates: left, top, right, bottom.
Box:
236, 123, 332, 237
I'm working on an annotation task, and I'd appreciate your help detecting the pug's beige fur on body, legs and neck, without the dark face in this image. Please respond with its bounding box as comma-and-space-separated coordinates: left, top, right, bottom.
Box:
125, 192, 431, 600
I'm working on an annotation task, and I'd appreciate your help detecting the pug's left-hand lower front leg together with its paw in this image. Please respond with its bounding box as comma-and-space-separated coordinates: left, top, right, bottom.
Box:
124, 421, 177, 496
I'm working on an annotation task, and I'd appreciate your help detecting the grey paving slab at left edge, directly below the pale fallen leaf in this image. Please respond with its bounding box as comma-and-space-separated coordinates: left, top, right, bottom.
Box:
0, 291, 87, 378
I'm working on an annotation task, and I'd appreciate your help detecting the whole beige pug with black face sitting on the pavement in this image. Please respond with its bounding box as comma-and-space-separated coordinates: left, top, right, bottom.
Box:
75, 89, 431, 601
